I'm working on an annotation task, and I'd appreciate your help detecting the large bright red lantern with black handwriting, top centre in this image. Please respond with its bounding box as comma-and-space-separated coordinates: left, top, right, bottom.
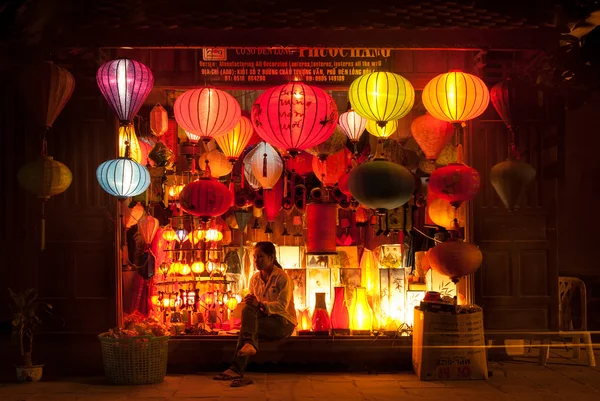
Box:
252, 82, 338, 156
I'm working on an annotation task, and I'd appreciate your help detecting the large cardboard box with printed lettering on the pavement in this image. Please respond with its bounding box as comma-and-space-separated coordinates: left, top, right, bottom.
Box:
412, 308, 488, 380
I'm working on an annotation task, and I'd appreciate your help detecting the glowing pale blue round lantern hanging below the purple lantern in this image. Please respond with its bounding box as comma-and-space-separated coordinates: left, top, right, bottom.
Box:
96, 157, 150, 199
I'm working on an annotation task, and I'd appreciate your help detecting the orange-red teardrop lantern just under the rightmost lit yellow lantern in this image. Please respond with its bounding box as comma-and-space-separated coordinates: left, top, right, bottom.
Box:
410, 113, 454, 160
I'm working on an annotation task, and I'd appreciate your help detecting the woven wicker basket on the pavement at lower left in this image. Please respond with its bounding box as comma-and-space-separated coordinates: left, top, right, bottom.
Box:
98, 333, 169, 384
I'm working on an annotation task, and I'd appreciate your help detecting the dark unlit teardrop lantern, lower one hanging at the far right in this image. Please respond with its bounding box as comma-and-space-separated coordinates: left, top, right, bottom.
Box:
490, 157, 536, 210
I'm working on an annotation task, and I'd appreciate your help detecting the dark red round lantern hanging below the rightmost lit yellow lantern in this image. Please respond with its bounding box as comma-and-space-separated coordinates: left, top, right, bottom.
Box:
429, 145, 481, 207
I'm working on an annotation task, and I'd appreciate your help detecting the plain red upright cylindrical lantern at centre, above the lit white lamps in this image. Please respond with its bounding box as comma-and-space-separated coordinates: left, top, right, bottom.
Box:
306, 203, 337, 255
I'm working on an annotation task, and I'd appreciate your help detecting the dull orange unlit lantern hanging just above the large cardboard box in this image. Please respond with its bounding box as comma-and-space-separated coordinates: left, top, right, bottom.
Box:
427, 240, 483, 283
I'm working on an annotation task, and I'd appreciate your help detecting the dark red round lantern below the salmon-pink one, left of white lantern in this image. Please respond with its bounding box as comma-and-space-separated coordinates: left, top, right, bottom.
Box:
179, 177, 231, 221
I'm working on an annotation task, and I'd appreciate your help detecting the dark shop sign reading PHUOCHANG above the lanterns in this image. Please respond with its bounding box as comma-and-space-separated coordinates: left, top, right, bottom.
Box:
199, 47, 392, 86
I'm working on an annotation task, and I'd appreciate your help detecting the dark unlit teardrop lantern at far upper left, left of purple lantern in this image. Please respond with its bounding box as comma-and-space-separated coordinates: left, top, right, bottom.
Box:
19, 61, 75, 128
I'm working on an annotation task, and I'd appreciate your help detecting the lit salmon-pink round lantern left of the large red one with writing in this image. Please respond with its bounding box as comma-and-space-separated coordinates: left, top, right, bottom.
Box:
173, 88, 242, 142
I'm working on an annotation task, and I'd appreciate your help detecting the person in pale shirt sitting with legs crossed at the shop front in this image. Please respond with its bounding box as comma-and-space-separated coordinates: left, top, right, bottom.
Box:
214, 241, 296, 387
